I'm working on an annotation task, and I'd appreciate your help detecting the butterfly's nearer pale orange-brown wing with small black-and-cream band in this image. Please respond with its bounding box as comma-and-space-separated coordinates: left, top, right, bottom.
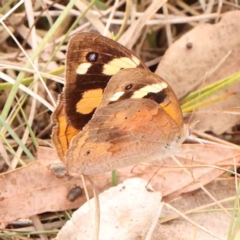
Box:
67, 69, 186, 175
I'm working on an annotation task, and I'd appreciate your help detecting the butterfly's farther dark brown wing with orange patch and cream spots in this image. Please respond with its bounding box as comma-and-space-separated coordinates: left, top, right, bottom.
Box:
52, 33, 147, 161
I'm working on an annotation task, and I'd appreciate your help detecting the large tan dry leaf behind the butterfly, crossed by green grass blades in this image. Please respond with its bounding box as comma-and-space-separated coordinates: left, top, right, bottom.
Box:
156, 11, 240, 134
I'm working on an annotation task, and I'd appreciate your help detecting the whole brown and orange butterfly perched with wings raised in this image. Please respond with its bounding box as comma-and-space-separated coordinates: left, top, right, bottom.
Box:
53, 33, 188, 175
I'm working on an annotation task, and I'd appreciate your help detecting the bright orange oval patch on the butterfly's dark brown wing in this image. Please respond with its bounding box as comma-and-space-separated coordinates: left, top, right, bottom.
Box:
76, 88, 103, 114
